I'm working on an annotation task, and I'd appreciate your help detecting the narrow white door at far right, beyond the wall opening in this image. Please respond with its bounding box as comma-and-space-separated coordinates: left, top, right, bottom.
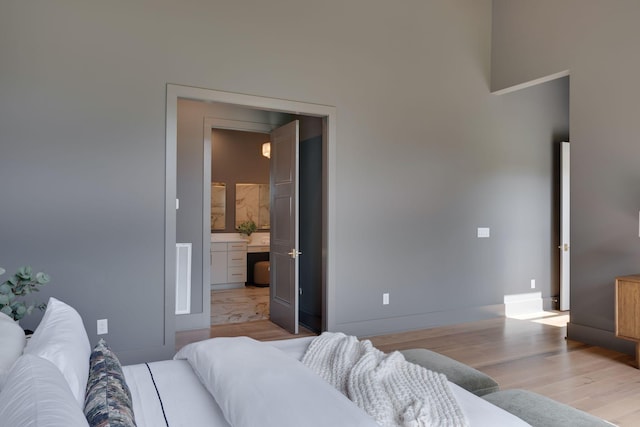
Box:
558, 142, 571, 311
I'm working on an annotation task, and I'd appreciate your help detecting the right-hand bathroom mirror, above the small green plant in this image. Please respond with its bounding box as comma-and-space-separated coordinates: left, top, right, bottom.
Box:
235, 184, 271, 230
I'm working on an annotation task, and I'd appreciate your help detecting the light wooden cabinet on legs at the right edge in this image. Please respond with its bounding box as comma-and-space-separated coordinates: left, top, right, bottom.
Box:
616, 274, 640, 368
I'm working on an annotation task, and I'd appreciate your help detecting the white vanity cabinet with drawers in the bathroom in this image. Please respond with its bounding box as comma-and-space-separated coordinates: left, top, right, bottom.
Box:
211, 242, 247, 289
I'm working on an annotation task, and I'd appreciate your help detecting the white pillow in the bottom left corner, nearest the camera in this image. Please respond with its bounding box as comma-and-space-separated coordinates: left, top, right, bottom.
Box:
0, 355, 88, 427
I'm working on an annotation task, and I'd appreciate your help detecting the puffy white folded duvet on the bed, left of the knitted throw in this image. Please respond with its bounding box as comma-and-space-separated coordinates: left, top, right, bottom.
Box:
174, 337, 379, 427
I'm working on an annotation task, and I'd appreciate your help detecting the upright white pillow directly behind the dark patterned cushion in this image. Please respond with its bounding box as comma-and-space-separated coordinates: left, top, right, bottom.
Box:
24, 298, 91, 408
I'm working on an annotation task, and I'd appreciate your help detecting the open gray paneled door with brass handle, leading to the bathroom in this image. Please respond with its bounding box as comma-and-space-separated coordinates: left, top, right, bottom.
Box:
269, 120, 301, 334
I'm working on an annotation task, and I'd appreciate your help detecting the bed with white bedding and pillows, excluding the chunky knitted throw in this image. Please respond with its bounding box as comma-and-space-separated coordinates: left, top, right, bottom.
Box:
0, 298, 604, 427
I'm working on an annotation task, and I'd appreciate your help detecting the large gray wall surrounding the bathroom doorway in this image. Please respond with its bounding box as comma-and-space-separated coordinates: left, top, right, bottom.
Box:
0, 0, 568, 363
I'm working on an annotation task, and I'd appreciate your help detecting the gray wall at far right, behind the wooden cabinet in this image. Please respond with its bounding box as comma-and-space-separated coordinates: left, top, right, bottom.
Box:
492, 0, 640, 351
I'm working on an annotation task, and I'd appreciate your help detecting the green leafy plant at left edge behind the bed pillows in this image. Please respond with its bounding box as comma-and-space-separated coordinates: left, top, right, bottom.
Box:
0, 266, 50, 321
